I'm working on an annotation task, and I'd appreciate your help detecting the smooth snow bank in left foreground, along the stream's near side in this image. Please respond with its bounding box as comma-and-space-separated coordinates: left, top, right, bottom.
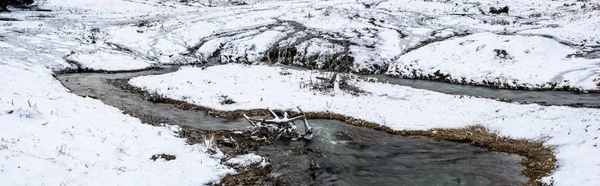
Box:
0, 63, 233, 185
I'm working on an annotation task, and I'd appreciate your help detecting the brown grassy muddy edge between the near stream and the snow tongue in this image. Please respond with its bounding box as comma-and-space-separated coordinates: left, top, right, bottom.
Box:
109, 79, 556, 185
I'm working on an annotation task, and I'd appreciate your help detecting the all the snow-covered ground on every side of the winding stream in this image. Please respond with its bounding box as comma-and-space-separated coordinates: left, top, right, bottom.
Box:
0, 0, 600, 185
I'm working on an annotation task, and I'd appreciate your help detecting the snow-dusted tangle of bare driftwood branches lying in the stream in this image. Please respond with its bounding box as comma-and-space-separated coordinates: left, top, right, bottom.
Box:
243, 107, 313, 139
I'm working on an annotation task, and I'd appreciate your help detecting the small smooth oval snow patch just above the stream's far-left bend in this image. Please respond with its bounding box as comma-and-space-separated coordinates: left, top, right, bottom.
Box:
66, 50, 153, 71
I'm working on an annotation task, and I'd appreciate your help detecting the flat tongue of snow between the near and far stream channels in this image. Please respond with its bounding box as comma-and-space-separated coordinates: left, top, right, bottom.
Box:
129, 64, 600, 185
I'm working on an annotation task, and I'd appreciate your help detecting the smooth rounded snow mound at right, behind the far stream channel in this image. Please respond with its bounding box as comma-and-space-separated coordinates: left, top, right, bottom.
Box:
387, 33, 600, 91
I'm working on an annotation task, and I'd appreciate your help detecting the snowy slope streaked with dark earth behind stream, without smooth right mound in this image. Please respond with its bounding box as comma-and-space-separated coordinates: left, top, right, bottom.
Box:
83, 0, 598, 73
